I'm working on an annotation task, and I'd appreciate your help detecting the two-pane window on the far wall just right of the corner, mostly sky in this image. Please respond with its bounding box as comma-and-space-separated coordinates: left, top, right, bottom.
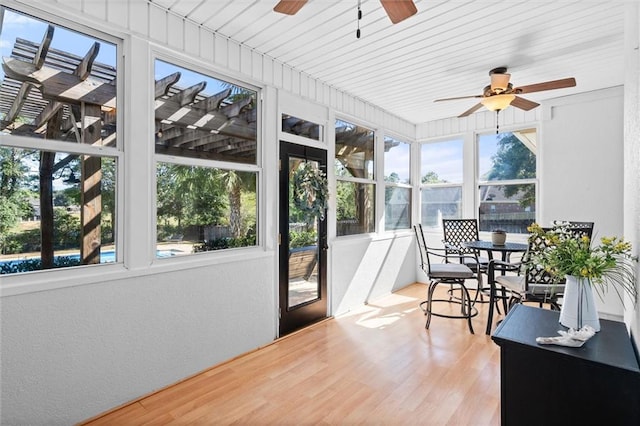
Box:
420, 139, 463, 228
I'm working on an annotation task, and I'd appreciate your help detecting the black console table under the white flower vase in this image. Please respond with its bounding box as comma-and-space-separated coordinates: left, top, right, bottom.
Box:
492, 305, 640, 426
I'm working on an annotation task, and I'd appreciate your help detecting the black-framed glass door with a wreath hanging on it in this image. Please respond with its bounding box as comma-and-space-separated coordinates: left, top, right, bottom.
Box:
279, 142, 328, 336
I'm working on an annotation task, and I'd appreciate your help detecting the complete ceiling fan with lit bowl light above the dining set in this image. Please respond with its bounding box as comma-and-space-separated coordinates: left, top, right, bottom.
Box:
434, 67, 576, 117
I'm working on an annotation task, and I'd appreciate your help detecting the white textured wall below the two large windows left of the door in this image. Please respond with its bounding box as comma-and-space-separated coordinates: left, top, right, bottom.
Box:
0, 255, 276, 425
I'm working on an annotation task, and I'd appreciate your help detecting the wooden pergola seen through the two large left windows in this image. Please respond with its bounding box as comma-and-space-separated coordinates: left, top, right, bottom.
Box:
0, 25, 257, 268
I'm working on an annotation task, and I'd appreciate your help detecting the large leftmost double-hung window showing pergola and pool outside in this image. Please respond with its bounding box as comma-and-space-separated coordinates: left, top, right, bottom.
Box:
0, 8, 122, 274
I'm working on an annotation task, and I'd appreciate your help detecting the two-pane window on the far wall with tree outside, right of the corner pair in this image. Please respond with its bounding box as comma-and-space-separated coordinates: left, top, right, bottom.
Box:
478, 129, 536, 233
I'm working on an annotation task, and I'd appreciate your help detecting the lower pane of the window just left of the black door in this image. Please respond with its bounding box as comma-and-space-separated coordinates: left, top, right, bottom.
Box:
156, 163, 257, 257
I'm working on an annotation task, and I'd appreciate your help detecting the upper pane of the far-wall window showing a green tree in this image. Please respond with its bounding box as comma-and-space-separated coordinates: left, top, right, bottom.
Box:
478, 129, 536, 181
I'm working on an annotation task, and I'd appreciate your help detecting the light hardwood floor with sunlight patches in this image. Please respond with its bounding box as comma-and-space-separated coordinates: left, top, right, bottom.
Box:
86, 284, 500, 426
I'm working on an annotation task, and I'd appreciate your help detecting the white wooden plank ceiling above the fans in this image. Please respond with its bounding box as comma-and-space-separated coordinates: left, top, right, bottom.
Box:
149, 0, 625, 123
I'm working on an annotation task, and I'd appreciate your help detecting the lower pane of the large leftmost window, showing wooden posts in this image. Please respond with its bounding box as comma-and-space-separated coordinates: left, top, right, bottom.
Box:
0, 147, 117, 274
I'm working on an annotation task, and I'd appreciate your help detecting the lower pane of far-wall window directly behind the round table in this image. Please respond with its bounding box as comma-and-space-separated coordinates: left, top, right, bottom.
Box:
479, 183, 536, 234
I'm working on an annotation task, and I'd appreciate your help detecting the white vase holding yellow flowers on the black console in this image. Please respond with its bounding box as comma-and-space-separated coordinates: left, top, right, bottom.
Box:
560, 275, 600, 331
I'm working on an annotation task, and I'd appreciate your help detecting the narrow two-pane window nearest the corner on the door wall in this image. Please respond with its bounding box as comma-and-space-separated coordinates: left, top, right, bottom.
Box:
384, 136, 411, 230
